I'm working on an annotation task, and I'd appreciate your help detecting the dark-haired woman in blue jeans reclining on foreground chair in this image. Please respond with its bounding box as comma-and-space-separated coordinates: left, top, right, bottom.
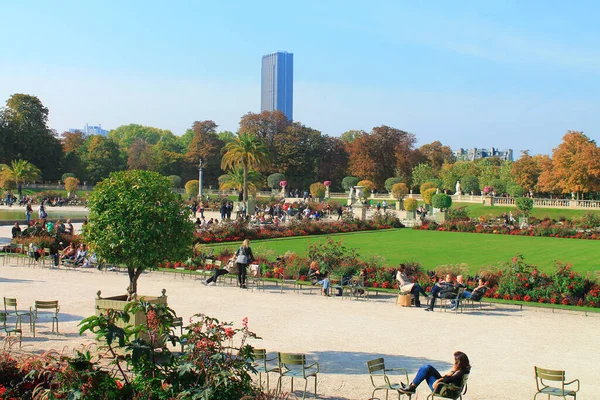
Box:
402, 351, 471, 397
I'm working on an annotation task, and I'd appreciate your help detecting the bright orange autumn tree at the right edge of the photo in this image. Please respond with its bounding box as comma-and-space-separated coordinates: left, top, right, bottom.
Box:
552, 131, 600, 199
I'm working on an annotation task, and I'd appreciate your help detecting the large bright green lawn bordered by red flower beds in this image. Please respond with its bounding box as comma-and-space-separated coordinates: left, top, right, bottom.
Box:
207, 229, 600, 275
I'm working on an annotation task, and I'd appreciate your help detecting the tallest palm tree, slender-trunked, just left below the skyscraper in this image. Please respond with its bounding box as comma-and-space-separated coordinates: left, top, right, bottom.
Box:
221, 133, 271, 201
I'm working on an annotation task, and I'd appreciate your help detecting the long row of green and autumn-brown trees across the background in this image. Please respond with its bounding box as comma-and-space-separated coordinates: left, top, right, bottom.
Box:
0, 94, 600, 197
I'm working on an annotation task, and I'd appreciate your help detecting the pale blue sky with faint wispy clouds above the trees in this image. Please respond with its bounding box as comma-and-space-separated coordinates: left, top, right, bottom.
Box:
0, 0, 600, 154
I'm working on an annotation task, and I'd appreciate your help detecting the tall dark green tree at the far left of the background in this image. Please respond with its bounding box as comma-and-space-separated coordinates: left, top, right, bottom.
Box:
0, 94, 63, 180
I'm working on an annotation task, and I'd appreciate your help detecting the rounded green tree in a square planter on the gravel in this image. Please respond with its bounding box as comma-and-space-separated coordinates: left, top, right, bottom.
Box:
83, 171, 194, 300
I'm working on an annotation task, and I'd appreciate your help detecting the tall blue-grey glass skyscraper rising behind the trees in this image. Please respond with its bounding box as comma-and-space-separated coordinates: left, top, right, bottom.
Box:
260, 51, 294, 121
